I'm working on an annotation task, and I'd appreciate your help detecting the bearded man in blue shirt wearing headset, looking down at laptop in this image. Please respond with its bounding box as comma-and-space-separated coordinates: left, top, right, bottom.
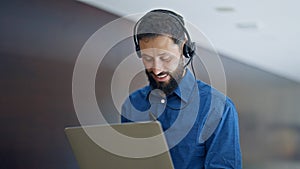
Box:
121, 10, 242, 169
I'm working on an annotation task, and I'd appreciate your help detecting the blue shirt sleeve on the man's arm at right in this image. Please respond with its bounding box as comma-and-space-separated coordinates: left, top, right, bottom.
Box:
205, 100, 242, 169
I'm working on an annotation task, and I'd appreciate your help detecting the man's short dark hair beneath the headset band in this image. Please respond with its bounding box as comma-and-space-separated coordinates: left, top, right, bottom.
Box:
136, 10, 186, 44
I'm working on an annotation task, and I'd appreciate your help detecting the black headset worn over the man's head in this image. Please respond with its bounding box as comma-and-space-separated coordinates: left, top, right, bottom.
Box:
133, 9, 196, 59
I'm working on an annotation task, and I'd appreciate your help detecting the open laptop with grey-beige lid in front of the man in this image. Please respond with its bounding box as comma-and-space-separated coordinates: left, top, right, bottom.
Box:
65, 121, 174, 169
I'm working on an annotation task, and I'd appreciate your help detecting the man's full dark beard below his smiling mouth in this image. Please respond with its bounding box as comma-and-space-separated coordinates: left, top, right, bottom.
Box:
145, 59, 185, 95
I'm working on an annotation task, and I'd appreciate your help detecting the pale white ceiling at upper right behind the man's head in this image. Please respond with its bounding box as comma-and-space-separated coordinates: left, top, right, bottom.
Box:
82, 0, 300, 82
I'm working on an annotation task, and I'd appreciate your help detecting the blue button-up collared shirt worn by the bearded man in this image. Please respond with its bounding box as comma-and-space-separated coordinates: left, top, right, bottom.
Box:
121, 71, 242, 169
